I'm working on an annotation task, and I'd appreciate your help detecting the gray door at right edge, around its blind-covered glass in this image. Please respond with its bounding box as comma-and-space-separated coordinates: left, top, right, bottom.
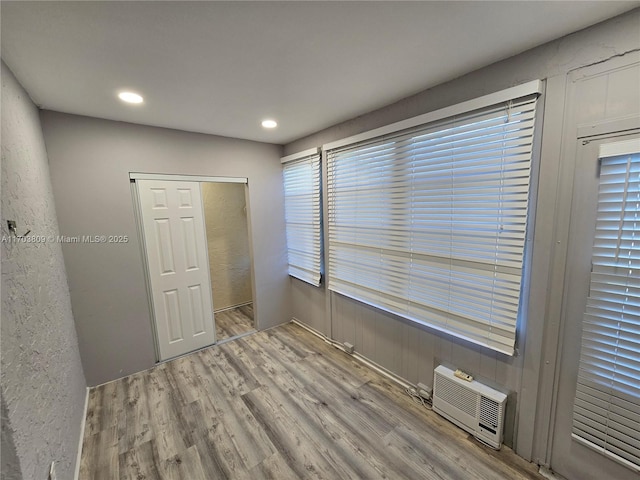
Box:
551, 134, 638, 480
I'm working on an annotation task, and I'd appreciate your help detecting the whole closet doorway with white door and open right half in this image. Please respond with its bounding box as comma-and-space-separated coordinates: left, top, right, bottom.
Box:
130, 173, 255, 361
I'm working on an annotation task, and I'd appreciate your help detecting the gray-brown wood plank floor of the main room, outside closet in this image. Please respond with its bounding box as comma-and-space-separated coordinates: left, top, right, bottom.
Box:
80, 324, 542, 480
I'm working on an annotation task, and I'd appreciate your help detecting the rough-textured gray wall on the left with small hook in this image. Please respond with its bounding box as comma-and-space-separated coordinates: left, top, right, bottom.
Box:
1, 63, 86, 479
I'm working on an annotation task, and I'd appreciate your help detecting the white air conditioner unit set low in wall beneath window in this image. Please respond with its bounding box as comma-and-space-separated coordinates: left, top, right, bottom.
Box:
433, 365, 507, 449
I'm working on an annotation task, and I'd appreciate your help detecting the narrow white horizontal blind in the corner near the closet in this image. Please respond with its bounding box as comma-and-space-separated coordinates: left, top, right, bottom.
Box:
283, 153, 322, 286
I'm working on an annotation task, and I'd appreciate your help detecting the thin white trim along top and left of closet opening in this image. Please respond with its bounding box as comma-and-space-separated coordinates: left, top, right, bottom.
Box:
129, 172, 249, 363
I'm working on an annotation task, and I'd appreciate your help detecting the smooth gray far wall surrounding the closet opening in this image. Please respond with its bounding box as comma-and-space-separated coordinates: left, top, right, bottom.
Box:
41, 111, 291, 385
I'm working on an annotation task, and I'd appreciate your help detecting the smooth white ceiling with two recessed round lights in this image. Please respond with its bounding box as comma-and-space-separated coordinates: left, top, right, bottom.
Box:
1, 1, 639, 143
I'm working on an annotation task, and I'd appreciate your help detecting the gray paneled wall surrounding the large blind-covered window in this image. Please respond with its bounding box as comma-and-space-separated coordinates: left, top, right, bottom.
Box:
285, 9, 640, 463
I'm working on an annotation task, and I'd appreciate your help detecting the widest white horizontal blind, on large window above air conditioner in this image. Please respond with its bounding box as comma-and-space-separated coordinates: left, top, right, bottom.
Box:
327, 96, 537, 354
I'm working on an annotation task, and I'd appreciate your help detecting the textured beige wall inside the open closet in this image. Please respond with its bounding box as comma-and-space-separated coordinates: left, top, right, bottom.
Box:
202, 182, 252, 310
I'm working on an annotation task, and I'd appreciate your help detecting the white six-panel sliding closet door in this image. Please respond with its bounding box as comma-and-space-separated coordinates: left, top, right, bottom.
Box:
138, 180, 216, 360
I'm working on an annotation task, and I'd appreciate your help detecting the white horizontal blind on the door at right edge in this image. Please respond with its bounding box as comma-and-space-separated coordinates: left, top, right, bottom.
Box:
573, 148, 640, 471
